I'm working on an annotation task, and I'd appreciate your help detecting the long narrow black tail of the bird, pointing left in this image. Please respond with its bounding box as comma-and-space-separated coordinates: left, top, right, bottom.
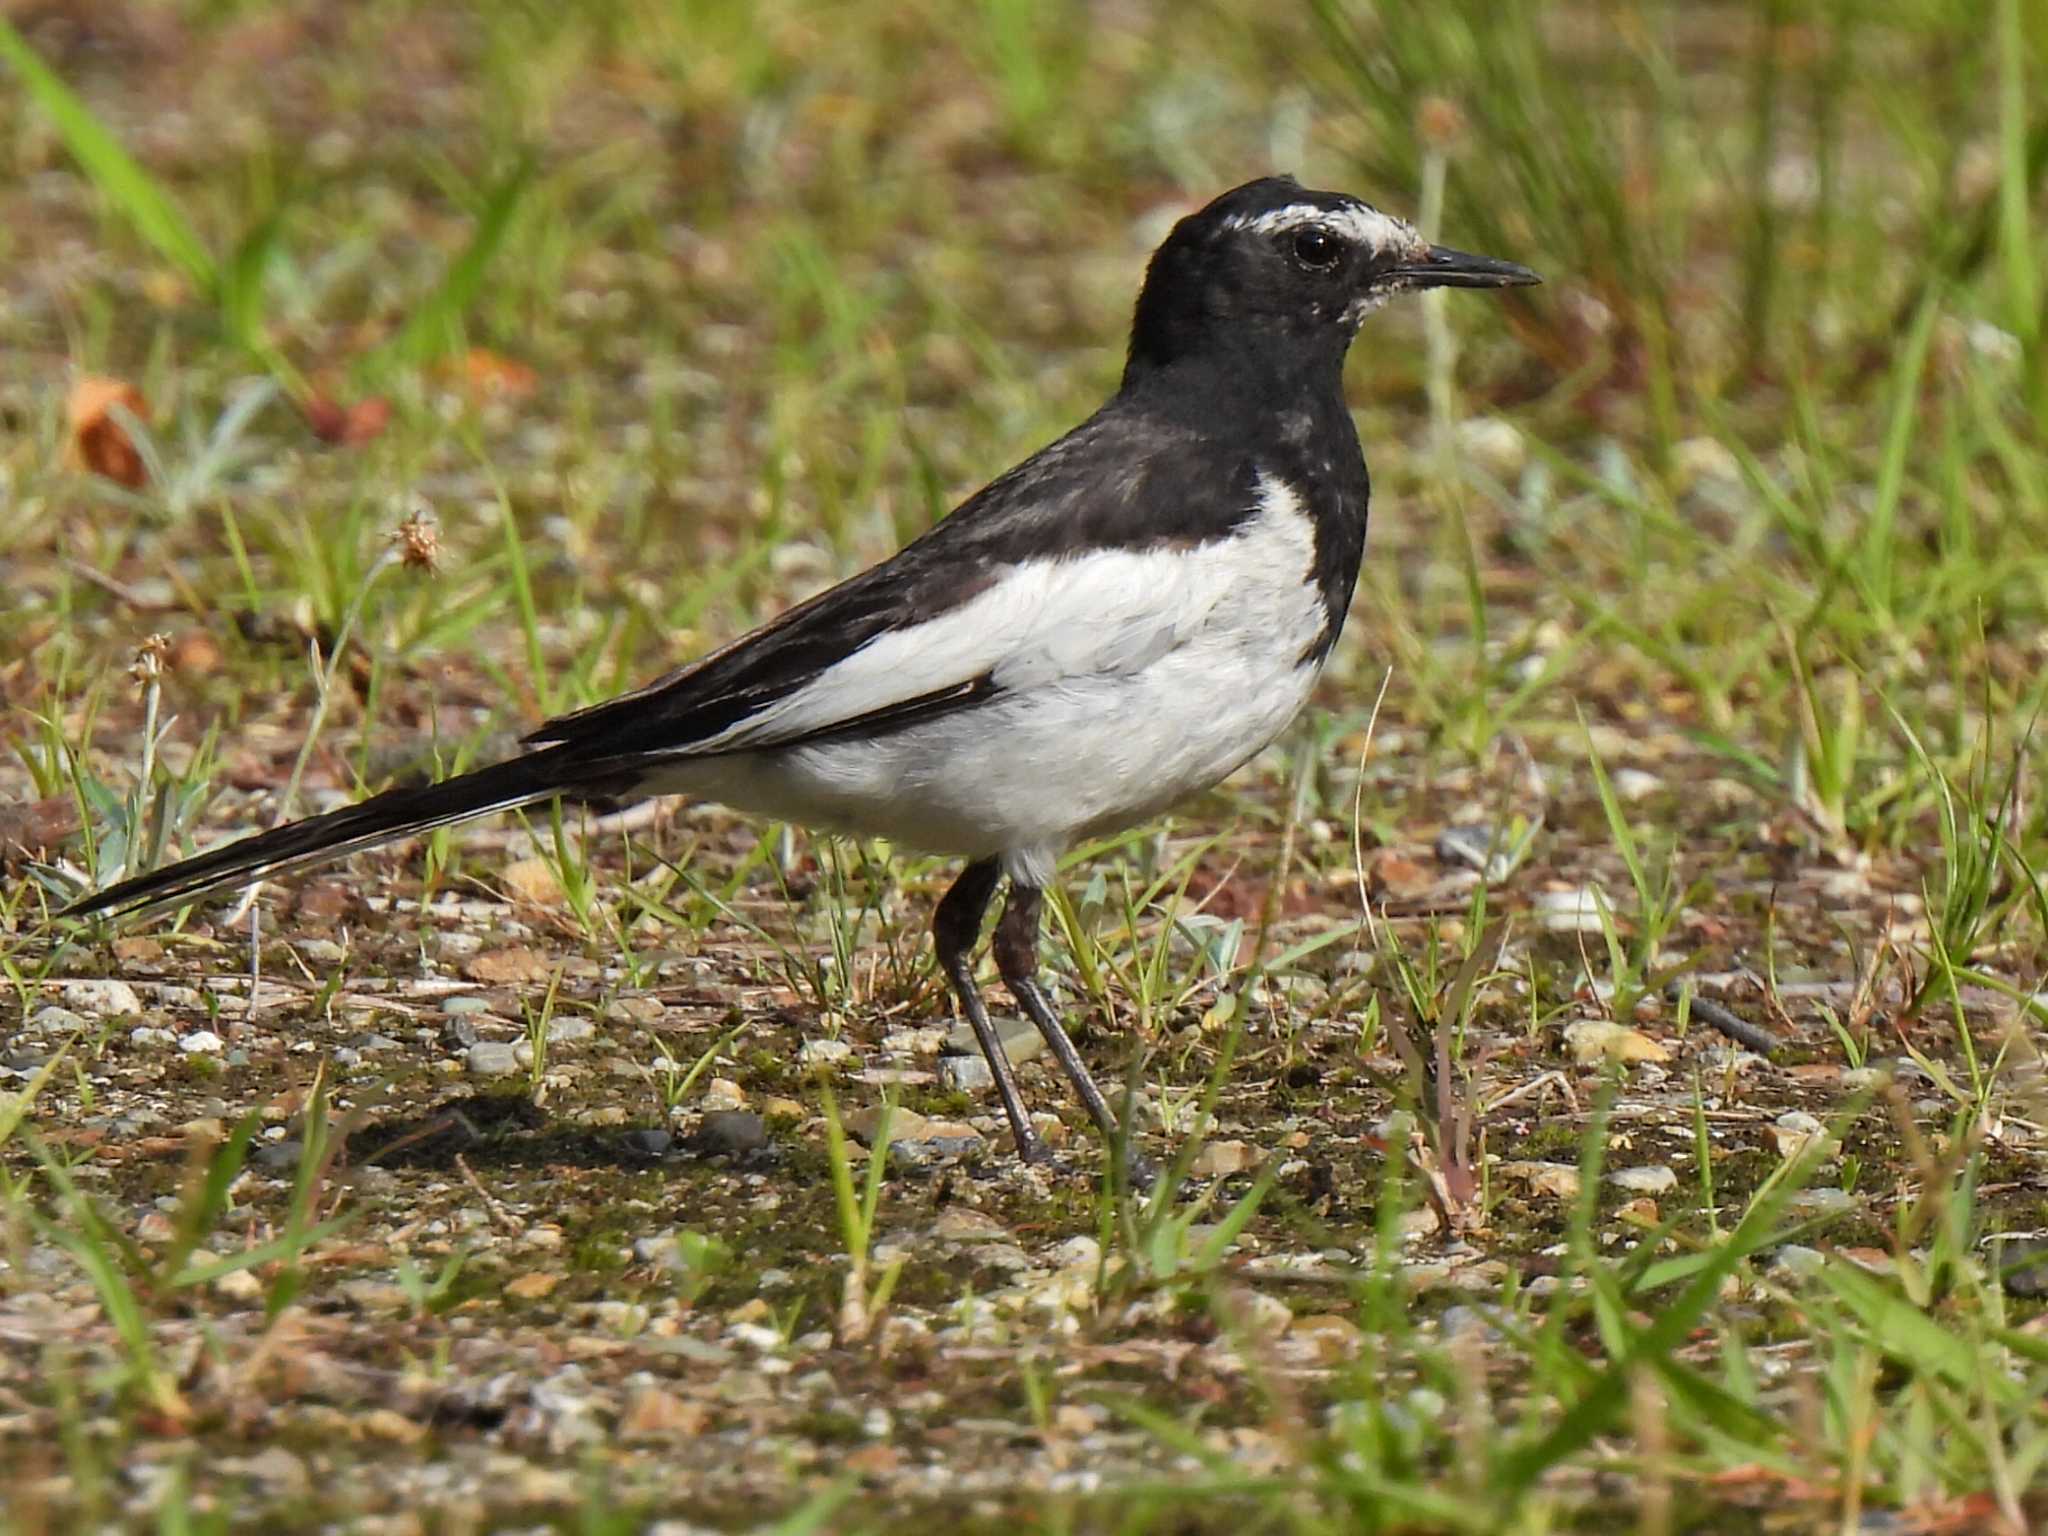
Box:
59, 748, 616, 918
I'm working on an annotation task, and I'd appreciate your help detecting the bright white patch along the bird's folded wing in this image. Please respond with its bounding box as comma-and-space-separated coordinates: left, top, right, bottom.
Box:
684, 475, 1315, 756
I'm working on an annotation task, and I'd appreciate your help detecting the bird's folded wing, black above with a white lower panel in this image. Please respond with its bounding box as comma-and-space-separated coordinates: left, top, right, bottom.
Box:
526, 410, 1257, 760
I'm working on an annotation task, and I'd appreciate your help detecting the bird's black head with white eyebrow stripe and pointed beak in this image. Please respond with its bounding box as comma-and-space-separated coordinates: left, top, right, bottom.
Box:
1130, 176, 1542, 385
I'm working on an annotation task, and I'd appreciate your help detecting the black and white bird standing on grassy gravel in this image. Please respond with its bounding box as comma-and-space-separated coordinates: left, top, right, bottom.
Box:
70, 176, 1538, 1159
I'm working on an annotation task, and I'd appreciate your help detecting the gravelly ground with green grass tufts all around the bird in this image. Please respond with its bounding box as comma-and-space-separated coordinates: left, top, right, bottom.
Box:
0, 0, 2048, 1536
